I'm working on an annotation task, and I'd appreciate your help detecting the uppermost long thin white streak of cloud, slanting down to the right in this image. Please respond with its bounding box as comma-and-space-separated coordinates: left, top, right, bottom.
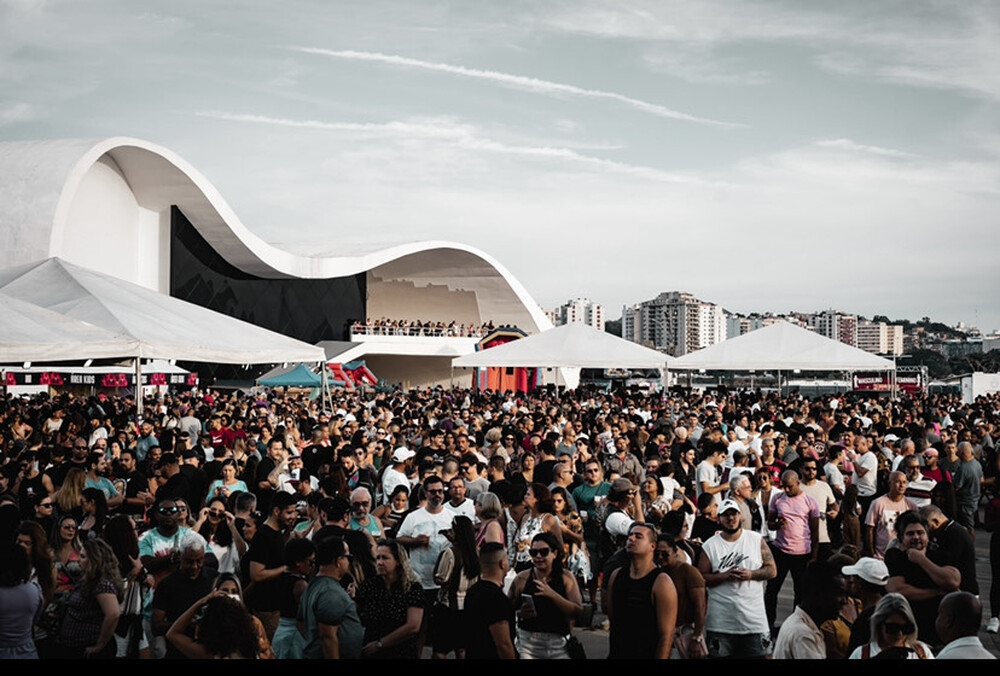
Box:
290, 47, 746, 128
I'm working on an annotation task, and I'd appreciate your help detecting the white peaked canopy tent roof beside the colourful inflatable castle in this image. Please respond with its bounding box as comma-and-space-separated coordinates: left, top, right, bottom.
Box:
452, 322, 673, 386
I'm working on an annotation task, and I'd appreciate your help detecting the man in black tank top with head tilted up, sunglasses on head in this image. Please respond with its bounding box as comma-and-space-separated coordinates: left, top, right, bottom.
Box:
608, 523, 677, 659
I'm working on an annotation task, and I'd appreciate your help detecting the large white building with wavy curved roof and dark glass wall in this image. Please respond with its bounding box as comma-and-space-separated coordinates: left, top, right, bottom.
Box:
0, 137, 551, 386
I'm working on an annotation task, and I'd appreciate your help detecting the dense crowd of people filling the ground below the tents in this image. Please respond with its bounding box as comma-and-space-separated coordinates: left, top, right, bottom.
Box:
0, 388, 1000, 659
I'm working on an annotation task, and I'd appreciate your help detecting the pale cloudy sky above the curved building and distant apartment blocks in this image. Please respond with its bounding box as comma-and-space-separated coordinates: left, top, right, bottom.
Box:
0, 0, 1000, 331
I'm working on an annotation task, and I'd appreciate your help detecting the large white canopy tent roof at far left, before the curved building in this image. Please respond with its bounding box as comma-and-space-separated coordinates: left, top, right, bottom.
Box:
0, 258, 325, 412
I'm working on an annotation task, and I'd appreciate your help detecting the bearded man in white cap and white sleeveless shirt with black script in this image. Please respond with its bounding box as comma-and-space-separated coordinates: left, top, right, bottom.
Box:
698, 500, 777, 658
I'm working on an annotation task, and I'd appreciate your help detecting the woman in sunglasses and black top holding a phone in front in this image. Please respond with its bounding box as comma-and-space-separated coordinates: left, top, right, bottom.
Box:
510, 532, 583, 659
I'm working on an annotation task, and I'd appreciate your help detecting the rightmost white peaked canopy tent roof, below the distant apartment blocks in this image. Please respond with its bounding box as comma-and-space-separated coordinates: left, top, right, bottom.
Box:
670, 321, 896, 371
